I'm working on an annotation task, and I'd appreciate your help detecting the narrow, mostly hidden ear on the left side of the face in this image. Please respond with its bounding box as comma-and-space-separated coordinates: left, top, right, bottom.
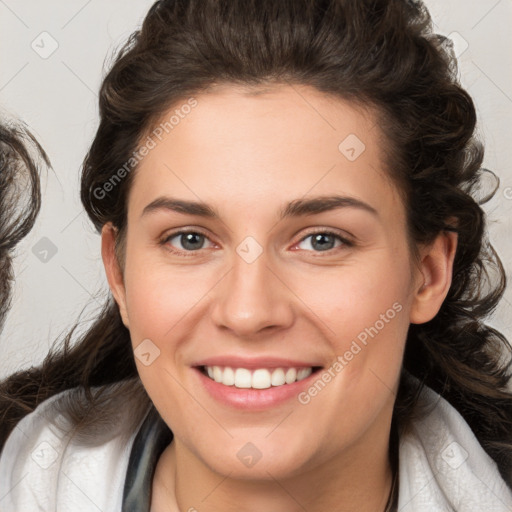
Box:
101, 222, 129, 328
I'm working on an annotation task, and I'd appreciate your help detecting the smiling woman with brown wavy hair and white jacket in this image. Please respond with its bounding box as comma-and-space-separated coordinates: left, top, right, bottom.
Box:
0, 0, 512, 512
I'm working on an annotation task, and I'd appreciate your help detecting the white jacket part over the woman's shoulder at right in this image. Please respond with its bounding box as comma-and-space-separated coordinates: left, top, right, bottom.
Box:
399, 387, 512, 512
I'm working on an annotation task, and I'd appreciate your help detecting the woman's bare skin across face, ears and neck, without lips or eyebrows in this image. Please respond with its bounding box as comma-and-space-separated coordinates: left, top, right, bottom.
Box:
102, 85, 456, 512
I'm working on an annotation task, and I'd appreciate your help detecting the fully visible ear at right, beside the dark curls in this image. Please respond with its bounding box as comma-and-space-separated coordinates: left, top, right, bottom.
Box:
410, 231, 457, 324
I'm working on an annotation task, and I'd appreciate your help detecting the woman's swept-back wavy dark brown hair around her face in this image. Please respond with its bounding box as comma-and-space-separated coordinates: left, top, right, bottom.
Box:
0, 0, 512, 482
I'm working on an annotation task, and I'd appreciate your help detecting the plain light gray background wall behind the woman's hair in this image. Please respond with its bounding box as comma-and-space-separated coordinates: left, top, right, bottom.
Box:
0, 0, 512, 378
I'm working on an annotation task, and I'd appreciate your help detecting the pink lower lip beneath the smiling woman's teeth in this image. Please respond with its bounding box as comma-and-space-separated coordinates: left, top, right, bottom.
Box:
193, 368, 319, 410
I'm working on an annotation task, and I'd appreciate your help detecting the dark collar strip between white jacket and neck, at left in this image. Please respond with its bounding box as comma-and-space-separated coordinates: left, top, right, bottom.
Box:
121, 405, 173, 512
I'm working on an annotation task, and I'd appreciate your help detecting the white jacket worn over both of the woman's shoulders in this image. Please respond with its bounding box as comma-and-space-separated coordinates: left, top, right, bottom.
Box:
0, 382, 512, 512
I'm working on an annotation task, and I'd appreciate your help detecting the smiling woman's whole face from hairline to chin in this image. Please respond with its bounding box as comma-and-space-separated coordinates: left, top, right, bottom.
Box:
104, 86, 448, 479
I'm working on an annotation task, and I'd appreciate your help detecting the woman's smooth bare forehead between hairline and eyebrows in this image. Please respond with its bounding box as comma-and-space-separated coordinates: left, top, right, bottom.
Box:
130, 85, 397, 220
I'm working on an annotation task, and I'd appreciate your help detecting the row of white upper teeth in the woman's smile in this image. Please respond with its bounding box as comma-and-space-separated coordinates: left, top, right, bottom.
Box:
206, 366, 313, 389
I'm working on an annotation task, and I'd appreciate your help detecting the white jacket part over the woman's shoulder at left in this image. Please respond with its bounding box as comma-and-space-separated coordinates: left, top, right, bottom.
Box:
0, 389, 151, 512
